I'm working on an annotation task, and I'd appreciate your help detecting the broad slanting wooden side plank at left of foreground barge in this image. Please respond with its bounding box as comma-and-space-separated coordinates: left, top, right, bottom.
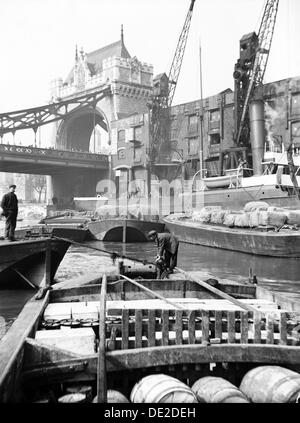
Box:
0, 291, 49, 403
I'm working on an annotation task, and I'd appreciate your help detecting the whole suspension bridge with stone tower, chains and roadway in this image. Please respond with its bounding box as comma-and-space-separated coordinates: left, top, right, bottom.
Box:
0, 29, 153, 204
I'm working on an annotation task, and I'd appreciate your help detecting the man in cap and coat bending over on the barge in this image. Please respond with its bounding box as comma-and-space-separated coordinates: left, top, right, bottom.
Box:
148, 230, 179, 273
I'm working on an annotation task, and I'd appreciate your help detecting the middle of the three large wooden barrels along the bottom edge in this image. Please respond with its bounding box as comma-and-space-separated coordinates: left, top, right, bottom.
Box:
192, 376, 249, 403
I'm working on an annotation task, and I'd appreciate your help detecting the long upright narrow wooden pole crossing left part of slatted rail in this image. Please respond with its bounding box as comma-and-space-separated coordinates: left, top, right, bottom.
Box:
97, 273, 107, 403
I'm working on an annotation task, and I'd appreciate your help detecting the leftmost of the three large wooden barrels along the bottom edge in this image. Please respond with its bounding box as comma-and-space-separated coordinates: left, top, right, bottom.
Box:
130, 374, 198, 403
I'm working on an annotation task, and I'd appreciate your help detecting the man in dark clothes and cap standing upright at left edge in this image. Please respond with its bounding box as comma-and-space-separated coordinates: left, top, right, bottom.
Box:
1, 184, 18, 241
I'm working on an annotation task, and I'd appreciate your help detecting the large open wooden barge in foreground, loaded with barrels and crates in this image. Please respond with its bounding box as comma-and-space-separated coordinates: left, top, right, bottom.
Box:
0, 264, 300, 402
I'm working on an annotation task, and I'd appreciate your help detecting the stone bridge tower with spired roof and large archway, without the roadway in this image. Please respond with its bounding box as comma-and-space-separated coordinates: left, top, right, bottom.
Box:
47, 26, 153, 205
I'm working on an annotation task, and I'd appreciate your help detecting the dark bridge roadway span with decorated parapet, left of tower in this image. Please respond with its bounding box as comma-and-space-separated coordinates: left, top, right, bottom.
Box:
0, 144, 109, 175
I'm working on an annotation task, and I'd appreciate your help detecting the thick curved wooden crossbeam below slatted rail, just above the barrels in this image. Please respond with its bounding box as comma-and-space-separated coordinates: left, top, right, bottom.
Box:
23, 344, 300, 386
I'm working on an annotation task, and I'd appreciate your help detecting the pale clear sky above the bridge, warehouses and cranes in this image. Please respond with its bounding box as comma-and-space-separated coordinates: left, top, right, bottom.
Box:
0, 0, 300, 113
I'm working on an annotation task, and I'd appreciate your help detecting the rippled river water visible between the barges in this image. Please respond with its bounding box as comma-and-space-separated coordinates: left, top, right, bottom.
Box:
0, 237, 300, 335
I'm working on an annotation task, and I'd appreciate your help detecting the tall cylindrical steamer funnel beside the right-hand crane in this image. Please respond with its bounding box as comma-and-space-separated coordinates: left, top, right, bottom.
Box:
249, 100, 265, 175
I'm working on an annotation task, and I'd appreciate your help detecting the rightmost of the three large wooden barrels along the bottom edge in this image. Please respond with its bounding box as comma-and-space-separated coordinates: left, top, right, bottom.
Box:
240, 366, 300, 403
